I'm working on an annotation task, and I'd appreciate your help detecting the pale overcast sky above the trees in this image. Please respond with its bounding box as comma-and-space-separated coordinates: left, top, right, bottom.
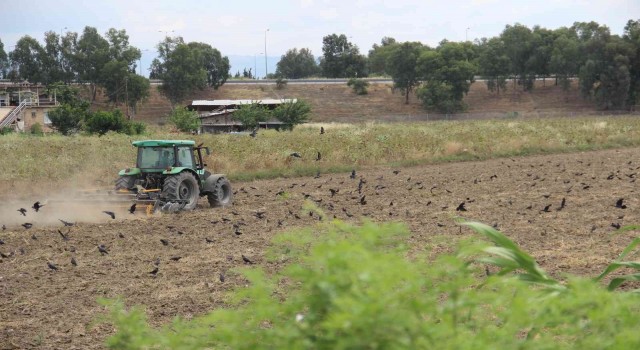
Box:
0, 0, 640, 77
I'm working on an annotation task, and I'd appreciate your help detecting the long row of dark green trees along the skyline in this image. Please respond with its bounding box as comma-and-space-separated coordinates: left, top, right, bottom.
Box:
0, 20, 640, 113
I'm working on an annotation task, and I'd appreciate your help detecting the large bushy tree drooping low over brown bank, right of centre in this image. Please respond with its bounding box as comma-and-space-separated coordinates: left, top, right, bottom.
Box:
418, 41, 477, 113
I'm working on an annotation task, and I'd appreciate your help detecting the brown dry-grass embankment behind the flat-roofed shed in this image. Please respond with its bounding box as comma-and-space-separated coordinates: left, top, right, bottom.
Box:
131, 79, 597, 123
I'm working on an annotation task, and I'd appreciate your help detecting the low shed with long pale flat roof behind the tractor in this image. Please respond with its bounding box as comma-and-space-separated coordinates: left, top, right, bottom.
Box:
187, 99, 297, 133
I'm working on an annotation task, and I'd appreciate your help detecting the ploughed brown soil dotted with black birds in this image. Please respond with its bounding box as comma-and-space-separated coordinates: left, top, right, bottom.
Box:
0, 149, 640, 349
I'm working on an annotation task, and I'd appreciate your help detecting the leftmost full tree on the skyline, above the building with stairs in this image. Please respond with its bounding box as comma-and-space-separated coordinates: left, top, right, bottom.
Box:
9, 35, 44, 83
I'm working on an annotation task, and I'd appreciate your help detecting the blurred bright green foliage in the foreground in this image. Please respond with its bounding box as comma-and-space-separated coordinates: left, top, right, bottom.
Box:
104, 222, 640, 349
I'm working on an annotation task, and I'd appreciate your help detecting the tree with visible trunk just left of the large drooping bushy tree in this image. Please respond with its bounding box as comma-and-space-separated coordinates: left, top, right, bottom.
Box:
385, 42, 426, 104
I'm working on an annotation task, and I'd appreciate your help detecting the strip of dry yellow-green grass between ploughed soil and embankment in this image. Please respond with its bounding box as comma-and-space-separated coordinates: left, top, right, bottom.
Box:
0, 117, 640, 184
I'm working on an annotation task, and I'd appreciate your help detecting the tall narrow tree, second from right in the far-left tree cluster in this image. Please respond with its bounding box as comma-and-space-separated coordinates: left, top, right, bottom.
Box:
74, 27, 110, 101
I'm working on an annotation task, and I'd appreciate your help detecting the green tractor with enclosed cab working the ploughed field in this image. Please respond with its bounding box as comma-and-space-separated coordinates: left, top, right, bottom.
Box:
115, 140, 233, 212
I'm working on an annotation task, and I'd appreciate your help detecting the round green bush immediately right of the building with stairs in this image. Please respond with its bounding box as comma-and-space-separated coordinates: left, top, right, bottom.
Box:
48, 84, 91, 135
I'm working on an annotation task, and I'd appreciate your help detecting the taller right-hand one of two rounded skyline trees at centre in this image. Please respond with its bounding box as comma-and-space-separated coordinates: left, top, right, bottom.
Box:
320, 34, 367, 78
